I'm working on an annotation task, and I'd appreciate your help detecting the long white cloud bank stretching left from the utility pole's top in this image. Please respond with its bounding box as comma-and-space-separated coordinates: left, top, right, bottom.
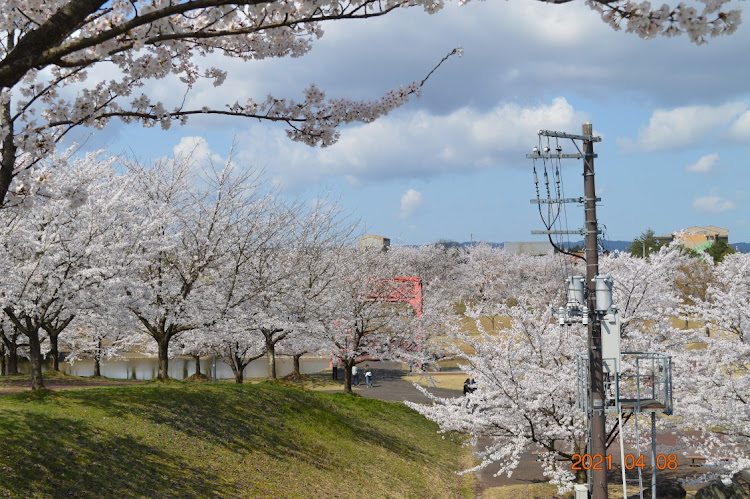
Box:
238, 97, 586, 187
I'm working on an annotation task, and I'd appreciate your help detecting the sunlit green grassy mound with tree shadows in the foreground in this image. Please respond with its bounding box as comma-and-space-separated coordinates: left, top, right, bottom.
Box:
0, 383, 473, 498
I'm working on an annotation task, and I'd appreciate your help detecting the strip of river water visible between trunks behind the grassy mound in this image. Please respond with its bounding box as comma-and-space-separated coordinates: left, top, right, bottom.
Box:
18, 357, 329, 379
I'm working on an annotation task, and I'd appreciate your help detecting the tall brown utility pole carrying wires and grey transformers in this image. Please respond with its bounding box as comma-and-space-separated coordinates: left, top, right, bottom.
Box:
582, 123, 607, 499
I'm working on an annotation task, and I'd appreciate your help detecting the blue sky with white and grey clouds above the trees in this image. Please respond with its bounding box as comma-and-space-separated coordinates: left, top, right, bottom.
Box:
66, 0, 750, 244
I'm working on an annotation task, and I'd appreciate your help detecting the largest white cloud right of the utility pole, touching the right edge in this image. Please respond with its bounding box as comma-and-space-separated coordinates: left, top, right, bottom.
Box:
617, 102, 747, 152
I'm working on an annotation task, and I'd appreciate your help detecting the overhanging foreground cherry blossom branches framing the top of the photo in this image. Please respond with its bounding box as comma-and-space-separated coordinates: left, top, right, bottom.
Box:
0, 0, 740, 206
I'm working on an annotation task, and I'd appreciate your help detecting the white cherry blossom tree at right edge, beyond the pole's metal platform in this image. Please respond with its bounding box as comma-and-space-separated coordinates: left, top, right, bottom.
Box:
675, 253, 750, 474
